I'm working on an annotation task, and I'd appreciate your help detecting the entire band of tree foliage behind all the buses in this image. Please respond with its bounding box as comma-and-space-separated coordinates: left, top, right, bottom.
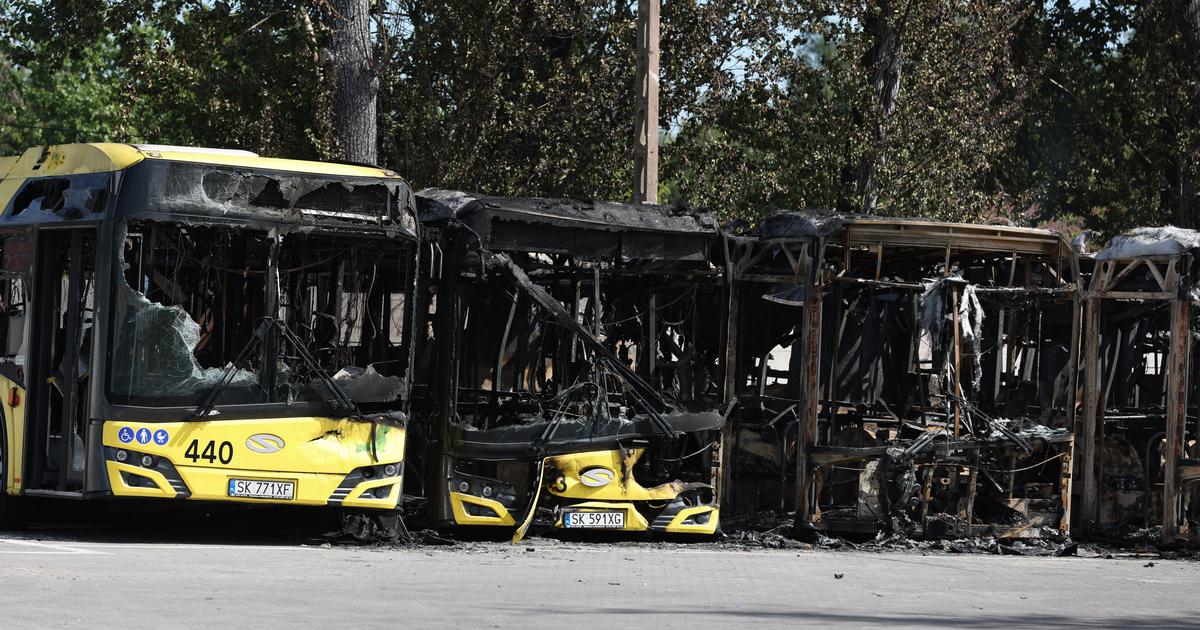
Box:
0, 0, 1200, 234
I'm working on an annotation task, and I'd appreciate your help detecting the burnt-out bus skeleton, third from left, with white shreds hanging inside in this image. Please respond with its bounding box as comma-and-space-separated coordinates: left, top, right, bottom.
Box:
733, 212, 1081, 538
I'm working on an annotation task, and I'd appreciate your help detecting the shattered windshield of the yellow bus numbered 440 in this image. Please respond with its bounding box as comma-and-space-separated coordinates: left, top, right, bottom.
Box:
108, 221, 412, 415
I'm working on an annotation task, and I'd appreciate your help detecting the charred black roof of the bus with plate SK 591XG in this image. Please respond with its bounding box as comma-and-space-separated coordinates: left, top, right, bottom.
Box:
416, 188, 719, 262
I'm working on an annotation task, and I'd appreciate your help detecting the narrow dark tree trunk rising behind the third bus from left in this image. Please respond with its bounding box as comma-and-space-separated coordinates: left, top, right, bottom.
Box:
858, 0, 907, 215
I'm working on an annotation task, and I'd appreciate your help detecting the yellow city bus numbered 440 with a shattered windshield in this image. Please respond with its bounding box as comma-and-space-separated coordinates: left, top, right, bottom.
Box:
0, 144, 419, 527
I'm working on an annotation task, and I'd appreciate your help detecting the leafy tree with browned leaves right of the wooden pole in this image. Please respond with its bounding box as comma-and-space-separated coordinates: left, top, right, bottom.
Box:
664, 1, 1031, 220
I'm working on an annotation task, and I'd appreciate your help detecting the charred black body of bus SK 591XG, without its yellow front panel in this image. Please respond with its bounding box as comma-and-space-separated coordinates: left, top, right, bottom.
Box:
410, 192, 722, 518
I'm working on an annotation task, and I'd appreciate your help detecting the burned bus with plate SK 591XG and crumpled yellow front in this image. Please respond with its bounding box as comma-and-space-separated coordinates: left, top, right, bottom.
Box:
409, 190, 728, 539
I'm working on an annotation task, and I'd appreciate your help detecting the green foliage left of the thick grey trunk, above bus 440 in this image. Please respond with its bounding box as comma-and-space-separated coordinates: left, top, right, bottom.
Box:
0, 0, 328, 156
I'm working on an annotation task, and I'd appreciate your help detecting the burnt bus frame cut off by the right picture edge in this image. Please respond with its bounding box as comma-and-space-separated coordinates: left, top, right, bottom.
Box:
1076, 227, 1200, 545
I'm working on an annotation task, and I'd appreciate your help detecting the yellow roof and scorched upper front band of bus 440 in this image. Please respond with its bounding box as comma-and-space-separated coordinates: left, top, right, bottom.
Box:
0, 144, 416, 239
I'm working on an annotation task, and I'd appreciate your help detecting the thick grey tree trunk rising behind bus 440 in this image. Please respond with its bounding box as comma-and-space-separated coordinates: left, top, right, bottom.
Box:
329, 0, 379, 164
